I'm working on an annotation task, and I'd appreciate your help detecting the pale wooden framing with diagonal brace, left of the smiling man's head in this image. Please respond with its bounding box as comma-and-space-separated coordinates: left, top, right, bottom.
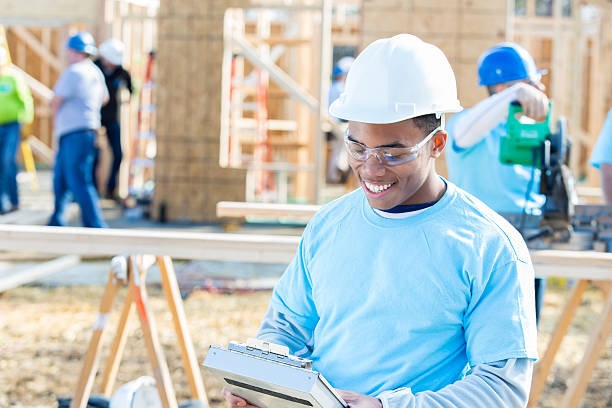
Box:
219, 0, 332, 202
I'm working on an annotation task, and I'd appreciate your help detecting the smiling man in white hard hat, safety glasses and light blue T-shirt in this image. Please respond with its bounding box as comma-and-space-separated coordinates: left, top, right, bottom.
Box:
224, 34, 537, 408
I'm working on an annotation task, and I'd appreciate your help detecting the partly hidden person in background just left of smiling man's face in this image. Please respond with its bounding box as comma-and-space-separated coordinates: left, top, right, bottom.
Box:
326, 56, 355, 183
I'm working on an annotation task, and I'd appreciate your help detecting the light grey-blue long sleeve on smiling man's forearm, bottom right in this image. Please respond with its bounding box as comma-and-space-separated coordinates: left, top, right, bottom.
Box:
377, 358, 533, 408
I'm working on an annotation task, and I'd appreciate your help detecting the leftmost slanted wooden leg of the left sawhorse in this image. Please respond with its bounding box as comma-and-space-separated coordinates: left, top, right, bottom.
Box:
70, 270, 119, 408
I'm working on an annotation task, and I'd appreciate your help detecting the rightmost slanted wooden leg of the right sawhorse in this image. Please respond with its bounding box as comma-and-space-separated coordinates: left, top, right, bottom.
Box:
561, 286, 612, 408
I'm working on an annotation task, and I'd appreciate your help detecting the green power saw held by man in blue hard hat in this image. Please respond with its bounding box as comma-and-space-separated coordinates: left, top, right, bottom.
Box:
499, 101, 575, 242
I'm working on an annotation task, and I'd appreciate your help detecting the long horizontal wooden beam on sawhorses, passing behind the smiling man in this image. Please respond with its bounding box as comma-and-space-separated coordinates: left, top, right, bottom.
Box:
0, 225, 612, 280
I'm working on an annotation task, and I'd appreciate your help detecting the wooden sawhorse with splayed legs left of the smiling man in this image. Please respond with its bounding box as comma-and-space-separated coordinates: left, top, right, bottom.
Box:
70, 255, 208, 408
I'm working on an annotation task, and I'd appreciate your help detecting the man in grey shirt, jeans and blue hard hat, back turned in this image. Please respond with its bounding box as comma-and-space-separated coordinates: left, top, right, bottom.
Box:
49, 31, 108, 228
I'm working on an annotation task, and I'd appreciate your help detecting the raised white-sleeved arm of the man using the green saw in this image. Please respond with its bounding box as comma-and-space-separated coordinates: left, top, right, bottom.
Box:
450, 82, 548, 149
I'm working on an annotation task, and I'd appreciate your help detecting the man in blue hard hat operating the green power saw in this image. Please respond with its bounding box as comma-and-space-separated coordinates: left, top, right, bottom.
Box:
446, 43, 548, 326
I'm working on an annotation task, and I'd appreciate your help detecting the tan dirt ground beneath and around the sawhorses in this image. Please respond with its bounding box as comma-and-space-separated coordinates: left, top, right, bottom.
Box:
0, 282, 612, 408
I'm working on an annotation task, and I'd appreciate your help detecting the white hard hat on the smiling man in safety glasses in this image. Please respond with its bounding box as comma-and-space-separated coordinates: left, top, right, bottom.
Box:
329, 34, 463, 123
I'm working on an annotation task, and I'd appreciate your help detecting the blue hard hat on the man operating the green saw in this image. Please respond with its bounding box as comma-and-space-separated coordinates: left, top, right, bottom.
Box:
478, 42, 548, 86
